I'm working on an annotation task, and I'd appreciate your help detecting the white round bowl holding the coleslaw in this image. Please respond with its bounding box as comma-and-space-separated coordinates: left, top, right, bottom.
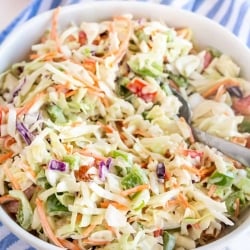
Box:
0, 1, 250, 250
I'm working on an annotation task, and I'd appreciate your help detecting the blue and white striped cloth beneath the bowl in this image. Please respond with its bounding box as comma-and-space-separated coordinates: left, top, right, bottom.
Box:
0, 0, 250, 250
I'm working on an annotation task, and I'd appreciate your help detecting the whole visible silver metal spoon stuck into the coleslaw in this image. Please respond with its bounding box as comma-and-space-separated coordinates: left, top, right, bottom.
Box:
171, 89, 250, 167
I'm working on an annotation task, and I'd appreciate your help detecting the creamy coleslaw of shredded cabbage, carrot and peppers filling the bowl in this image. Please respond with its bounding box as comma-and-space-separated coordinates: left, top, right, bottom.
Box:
0, 9, 250, 250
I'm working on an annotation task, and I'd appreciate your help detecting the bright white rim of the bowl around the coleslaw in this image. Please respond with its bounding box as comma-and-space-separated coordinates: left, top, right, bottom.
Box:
0, 0, 250, 250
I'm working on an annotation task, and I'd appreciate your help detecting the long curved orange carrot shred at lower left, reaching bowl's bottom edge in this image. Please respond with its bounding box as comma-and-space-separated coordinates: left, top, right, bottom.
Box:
36, 198, 64, 247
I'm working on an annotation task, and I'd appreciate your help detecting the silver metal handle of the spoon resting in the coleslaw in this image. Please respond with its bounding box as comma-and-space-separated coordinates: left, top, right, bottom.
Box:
192, 128, 250, 167
